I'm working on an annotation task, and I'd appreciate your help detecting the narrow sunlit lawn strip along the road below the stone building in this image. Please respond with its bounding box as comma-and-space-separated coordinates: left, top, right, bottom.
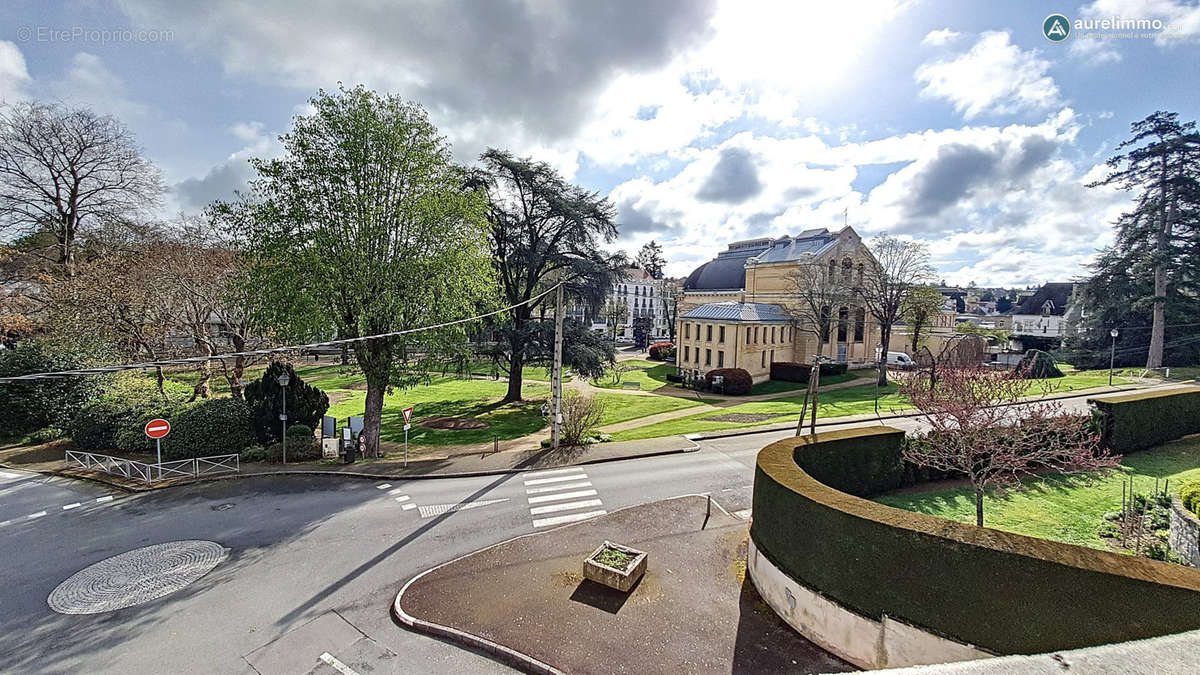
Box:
613, 384, 910, 441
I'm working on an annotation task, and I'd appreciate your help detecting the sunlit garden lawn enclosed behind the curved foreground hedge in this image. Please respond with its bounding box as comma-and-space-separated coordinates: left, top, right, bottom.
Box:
875, 437, 1200, 549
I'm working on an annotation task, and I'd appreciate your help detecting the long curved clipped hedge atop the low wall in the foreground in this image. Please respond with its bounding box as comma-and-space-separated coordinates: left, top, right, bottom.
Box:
750, 428, 1200, 655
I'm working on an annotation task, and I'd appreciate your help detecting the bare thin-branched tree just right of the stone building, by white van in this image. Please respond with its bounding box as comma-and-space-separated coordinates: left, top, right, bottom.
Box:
859, 234, 935, 387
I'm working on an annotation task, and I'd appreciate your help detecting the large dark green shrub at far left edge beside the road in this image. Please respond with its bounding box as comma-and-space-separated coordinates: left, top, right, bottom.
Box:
0, 340, 103, 434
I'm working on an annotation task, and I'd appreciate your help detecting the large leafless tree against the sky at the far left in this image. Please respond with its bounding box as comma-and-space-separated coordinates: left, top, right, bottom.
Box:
0, 102, 163, 277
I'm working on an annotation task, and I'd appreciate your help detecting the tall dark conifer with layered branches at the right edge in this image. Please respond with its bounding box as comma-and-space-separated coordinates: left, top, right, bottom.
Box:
1082, 110, 1200, 368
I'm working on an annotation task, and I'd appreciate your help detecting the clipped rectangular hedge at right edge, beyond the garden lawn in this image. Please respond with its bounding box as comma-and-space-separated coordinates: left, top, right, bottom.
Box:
1087, 388, 1200, 454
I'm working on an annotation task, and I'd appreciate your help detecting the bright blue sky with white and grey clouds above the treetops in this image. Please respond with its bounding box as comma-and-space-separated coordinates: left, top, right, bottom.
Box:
0, 0, 1200, 286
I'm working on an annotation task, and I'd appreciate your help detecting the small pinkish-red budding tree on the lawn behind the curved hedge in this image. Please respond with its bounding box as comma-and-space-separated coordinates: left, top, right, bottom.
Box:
901, 366, 1117, 527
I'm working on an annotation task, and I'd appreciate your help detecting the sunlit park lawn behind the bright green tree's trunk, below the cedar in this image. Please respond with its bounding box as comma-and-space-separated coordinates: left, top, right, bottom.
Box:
328, 376, 550, 446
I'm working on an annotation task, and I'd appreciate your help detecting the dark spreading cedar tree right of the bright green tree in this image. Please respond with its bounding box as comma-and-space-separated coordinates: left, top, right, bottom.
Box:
472, 149, 628, 402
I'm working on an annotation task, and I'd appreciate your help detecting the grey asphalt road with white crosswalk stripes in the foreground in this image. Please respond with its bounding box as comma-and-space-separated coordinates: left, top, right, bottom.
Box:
0, 389, 1123, 674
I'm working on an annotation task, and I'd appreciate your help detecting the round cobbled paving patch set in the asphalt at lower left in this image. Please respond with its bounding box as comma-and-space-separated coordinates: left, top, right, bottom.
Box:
46, 540, 226, 614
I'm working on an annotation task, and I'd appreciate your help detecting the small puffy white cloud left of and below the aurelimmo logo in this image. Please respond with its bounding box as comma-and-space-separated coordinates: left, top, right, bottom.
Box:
916, 32, 1062, 119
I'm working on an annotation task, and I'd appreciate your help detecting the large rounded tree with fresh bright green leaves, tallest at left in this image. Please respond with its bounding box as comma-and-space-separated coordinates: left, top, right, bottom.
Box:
212, 85, 494, 455
